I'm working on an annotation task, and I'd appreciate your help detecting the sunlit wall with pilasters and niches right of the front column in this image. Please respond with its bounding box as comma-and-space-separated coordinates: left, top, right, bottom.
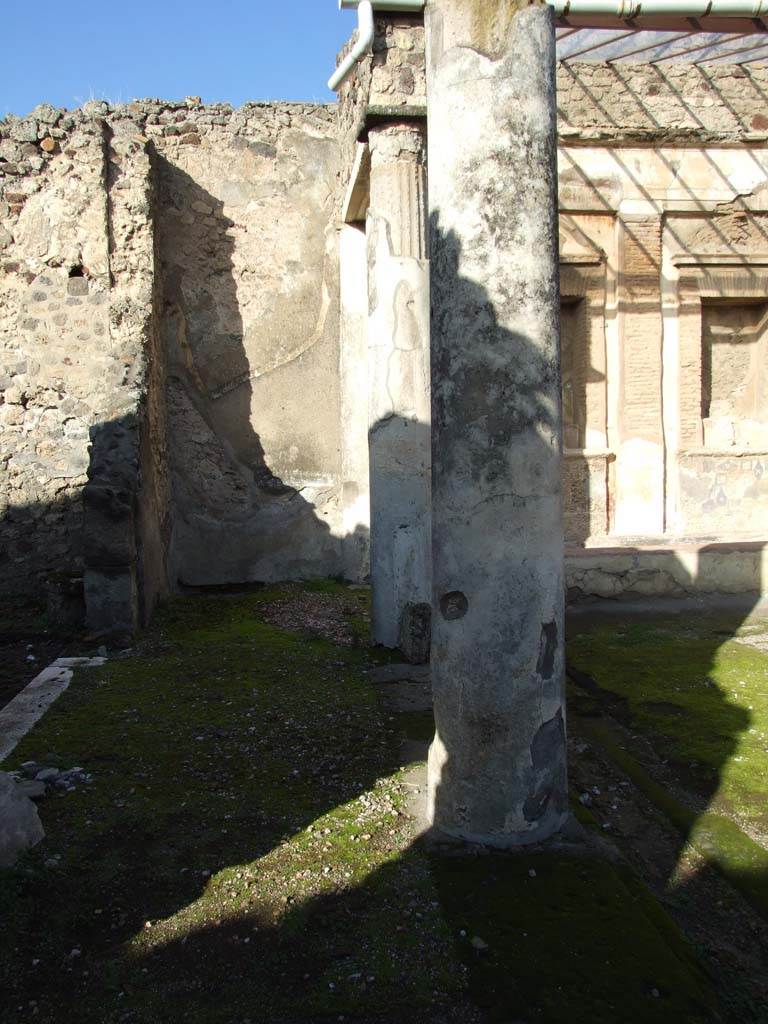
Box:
558, 62, 768, 596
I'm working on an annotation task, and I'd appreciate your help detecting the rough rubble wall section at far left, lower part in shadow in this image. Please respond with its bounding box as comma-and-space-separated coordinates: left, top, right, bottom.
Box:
0, 104, 168, 632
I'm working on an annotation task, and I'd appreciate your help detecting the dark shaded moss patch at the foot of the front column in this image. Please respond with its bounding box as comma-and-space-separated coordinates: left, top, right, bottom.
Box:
436, 853, 714, 1024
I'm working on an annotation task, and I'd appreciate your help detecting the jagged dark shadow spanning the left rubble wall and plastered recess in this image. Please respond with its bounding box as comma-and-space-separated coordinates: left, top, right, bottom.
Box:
0, 154, 360, 633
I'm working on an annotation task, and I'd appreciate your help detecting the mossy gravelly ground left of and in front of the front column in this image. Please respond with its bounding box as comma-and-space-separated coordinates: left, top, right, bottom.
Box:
0, 583, 717, 1024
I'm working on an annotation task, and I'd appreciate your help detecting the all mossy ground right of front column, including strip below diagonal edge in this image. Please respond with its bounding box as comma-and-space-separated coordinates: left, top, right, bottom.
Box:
568, 613, 768, 920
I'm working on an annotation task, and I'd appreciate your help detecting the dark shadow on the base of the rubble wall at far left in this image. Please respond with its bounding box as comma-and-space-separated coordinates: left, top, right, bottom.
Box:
0, 414, 168, 638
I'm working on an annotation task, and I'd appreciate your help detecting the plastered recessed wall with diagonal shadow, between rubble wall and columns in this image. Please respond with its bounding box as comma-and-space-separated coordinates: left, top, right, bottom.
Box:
146, 104, 344, 585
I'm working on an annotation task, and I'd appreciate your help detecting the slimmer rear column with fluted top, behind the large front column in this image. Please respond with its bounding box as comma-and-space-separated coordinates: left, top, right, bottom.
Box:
367, 122, 431, 647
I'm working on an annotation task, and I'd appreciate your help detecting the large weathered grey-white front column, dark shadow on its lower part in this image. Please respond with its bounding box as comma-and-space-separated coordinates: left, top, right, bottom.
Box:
427, 0, 567, 847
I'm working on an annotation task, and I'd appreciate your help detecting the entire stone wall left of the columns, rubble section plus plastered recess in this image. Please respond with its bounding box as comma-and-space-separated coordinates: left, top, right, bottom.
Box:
0, 98, 343, 632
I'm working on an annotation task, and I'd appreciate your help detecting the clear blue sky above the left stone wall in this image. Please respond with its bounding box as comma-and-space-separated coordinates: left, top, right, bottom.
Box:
0, 0, 356, 117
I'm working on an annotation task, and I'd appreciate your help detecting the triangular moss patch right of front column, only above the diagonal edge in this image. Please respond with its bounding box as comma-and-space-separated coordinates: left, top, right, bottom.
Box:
568, 615, 768, 834
